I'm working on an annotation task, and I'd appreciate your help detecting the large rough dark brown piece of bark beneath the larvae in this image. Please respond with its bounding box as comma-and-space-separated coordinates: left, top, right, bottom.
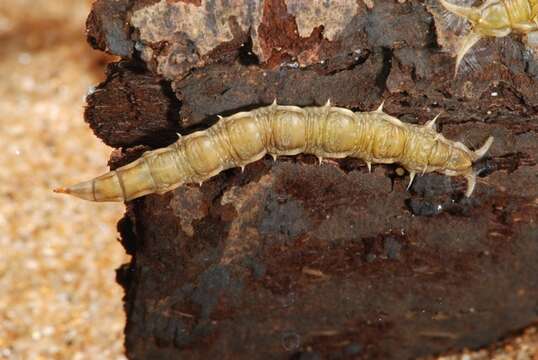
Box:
86, 0, 538, 359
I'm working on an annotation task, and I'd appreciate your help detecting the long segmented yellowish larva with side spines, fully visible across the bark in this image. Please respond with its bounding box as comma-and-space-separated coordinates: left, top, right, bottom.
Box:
55, 101, 493, 201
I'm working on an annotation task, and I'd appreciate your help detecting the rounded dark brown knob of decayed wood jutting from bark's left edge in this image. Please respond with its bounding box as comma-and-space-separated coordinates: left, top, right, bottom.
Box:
84, 62, 180, 147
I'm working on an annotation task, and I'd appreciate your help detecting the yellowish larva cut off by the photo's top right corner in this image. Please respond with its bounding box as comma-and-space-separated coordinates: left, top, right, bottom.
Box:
439, 0, 538, 74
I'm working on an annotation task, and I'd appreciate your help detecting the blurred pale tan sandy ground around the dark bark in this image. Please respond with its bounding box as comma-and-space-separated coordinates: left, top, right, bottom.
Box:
0, 0, 538, 360
